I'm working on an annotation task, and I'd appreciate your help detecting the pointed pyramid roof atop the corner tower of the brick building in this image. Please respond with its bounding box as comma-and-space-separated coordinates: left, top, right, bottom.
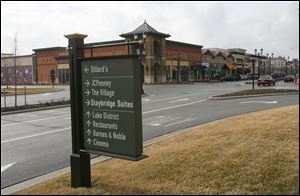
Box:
120, 20, 170, 37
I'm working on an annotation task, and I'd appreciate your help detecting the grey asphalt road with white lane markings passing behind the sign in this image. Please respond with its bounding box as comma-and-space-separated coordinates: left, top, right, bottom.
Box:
1, 82, 299, 189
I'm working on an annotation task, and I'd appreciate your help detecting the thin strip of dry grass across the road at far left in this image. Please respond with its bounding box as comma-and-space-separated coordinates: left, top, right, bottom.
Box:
1, 88, 64, 96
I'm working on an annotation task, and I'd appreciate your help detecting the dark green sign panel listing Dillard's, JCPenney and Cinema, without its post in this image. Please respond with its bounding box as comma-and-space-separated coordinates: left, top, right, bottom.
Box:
81, 56, 143, 157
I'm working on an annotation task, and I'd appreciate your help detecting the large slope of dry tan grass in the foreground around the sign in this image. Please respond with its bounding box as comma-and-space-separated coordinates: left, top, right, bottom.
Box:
17, 105, 299, 195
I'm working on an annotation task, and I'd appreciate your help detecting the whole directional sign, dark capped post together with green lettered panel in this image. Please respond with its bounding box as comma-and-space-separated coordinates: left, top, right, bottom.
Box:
65, 34, 147, 187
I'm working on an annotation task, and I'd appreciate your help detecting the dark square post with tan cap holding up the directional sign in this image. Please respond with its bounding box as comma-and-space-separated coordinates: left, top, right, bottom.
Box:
65, 34, 91, 188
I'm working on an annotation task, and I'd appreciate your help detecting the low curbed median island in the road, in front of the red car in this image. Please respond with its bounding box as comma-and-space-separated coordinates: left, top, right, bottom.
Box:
210, 89, 299, 100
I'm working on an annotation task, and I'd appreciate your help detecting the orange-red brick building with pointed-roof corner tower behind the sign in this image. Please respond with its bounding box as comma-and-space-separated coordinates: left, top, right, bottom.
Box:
33, 21, 203, 84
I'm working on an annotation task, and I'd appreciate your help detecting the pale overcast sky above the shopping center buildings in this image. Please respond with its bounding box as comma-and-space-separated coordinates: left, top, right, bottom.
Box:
1, 1, 299, 58
